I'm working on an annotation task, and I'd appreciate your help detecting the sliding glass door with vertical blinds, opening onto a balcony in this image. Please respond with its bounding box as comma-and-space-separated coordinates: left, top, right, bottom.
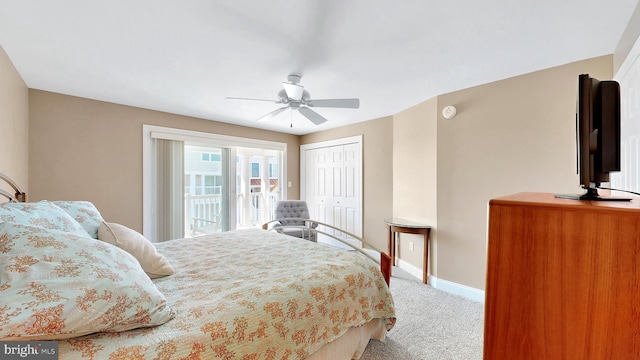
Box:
143, 125, 286, 241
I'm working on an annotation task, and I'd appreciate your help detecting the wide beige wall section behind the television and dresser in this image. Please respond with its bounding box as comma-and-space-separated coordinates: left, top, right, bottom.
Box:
436, 56, 613, 289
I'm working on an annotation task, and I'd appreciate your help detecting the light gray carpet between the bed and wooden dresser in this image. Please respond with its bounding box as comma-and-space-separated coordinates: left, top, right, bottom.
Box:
361, 267, 484, 360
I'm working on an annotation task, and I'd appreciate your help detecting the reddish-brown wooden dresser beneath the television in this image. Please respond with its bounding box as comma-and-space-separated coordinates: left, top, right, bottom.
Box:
484, 193, 640, 360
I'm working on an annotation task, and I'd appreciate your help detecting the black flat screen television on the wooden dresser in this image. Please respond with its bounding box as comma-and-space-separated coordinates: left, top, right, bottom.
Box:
556, 74, 630, 201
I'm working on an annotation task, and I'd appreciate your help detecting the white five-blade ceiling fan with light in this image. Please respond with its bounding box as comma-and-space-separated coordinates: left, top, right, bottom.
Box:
227, 74, 360, 126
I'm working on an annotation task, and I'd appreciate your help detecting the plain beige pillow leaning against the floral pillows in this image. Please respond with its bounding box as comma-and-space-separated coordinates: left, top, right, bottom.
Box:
98, 221, 176, 279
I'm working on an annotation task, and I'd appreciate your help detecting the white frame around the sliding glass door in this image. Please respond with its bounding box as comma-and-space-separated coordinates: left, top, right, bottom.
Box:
142, 124, 287, 236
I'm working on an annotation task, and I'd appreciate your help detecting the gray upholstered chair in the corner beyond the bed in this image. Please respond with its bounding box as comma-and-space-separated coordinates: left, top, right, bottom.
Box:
273, 200, 318, 242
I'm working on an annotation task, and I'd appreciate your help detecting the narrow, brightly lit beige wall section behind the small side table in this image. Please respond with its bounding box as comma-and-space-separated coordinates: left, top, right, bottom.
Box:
393, 99, 438, 276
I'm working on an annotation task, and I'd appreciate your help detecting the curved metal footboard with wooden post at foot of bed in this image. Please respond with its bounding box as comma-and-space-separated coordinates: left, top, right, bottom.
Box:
262, 218, 391, 285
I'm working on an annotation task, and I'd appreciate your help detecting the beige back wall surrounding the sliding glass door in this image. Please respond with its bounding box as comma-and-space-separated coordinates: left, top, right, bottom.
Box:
29, 90, 300, 231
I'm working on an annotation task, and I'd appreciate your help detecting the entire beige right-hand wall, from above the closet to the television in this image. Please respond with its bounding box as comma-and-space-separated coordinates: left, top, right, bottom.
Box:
301, 56, 613, 289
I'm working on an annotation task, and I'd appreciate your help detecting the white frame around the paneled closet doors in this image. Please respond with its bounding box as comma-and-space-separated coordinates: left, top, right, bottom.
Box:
300, 135, 364, 236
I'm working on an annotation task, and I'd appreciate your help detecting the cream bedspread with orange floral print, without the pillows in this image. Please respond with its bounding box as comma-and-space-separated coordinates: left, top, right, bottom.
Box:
59, 229, 395, 360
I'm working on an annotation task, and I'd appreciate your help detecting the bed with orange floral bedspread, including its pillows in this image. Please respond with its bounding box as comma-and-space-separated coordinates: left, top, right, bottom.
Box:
0, 174, 395, 359
